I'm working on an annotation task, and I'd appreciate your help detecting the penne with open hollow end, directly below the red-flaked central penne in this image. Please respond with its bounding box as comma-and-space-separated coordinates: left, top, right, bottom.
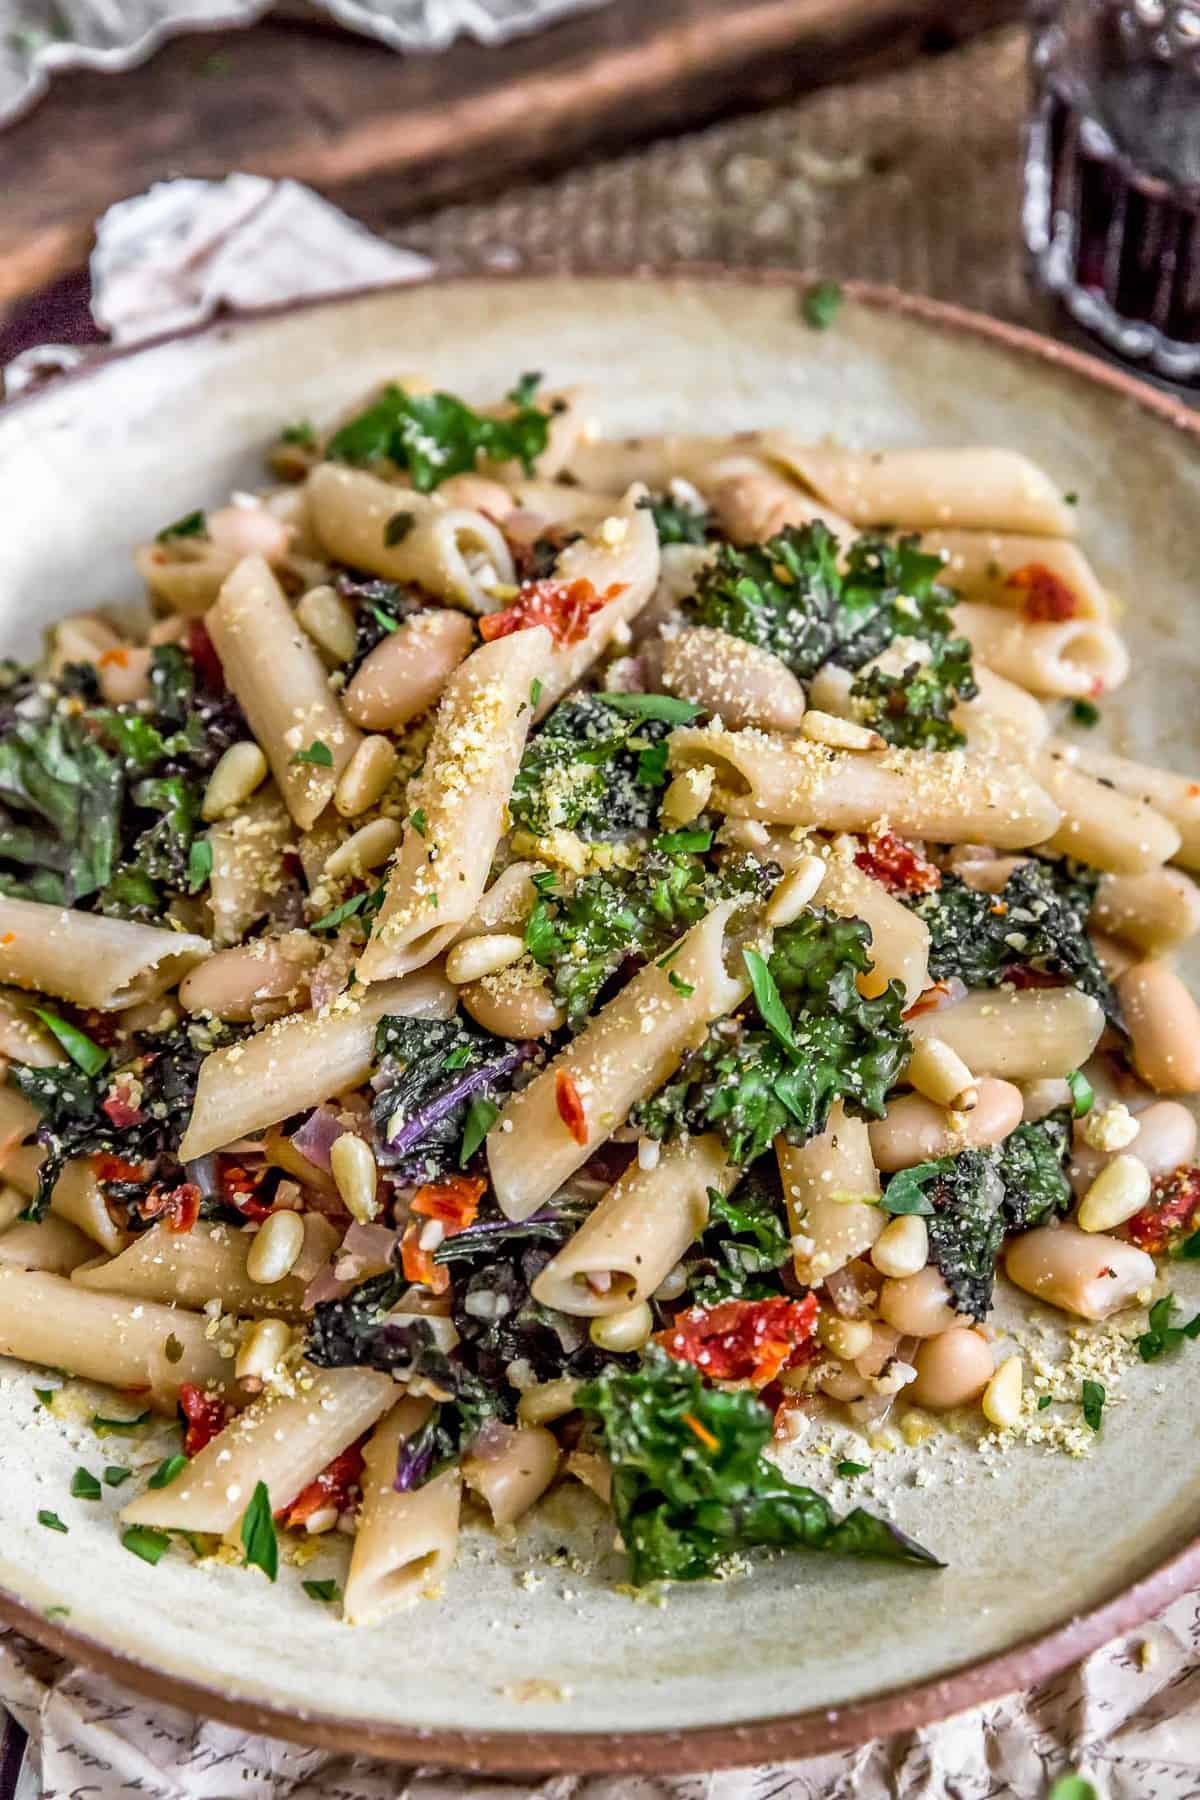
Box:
533, 1134, 741, 1318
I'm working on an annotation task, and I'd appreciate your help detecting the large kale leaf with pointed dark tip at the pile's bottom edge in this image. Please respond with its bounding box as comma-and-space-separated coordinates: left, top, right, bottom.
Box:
578, 1350, 941, 1588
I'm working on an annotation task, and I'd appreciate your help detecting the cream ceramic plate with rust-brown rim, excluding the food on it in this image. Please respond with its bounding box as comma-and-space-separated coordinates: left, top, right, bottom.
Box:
0, 275, 1200, 1769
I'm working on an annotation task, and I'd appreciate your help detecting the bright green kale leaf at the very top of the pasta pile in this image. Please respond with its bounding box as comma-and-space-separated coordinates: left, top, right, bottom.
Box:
326, 376, 551, 493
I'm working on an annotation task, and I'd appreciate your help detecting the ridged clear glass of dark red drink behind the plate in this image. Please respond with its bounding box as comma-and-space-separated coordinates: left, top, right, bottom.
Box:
1022, 0, 1200, 387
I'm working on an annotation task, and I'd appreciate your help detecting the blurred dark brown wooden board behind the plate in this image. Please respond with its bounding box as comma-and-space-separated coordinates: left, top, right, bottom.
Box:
0, 0, 1020, 302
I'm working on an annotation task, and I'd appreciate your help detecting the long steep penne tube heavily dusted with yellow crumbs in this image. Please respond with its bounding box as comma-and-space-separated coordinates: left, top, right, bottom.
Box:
354, 625, 551, 985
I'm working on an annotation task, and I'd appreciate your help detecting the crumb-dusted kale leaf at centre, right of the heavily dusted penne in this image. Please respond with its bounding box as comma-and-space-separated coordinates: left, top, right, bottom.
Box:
509, 695, 671, 837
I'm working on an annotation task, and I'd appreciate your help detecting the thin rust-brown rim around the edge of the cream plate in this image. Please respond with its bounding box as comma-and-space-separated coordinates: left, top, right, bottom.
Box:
0, 263, 1200, 1775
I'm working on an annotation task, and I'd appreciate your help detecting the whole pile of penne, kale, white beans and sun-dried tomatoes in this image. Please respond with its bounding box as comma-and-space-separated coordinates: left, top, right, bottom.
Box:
0, 376, 1200, 1624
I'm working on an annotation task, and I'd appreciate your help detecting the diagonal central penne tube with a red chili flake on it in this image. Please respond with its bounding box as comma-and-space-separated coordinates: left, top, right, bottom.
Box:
488, 900, 750, 1219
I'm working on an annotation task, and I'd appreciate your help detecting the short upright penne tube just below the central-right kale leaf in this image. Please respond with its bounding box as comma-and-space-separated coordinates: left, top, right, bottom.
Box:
775, 1100, 887, 1287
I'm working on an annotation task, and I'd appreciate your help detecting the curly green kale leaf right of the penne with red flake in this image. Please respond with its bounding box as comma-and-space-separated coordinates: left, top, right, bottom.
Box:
631, 909, 909, 1166
